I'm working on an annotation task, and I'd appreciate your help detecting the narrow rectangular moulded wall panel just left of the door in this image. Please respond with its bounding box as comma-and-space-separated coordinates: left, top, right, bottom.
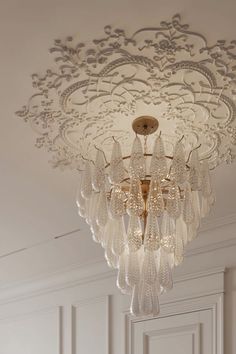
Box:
73, 296, 109, 354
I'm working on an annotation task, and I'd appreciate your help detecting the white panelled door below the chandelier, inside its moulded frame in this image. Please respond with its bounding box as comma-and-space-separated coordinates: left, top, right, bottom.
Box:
131, 309, 213, 354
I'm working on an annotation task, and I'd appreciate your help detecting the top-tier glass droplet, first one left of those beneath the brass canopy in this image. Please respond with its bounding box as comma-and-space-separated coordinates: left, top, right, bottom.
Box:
109, 141, 125, 184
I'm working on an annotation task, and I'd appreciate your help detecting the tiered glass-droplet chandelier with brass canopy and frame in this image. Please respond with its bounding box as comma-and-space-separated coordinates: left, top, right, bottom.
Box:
77, 116, 214, 316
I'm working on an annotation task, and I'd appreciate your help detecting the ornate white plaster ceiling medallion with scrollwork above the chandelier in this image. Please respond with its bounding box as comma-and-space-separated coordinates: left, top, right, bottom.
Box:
16, 15, 236, 170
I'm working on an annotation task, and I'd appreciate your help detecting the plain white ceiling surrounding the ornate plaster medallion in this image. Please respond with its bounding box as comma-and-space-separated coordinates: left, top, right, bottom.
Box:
0, 0, 236, 285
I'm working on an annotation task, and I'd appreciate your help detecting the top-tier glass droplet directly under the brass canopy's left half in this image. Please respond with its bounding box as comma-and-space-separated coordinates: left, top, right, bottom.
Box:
129, 136, 146, 179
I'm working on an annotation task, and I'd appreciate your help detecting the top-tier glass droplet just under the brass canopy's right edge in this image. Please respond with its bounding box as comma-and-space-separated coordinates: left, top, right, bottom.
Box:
150, 136, 168, 180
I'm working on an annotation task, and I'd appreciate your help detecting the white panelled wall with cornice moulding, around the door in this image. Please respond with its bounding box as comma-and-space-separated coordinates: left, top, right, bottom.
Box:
0, 220, 236, 354
